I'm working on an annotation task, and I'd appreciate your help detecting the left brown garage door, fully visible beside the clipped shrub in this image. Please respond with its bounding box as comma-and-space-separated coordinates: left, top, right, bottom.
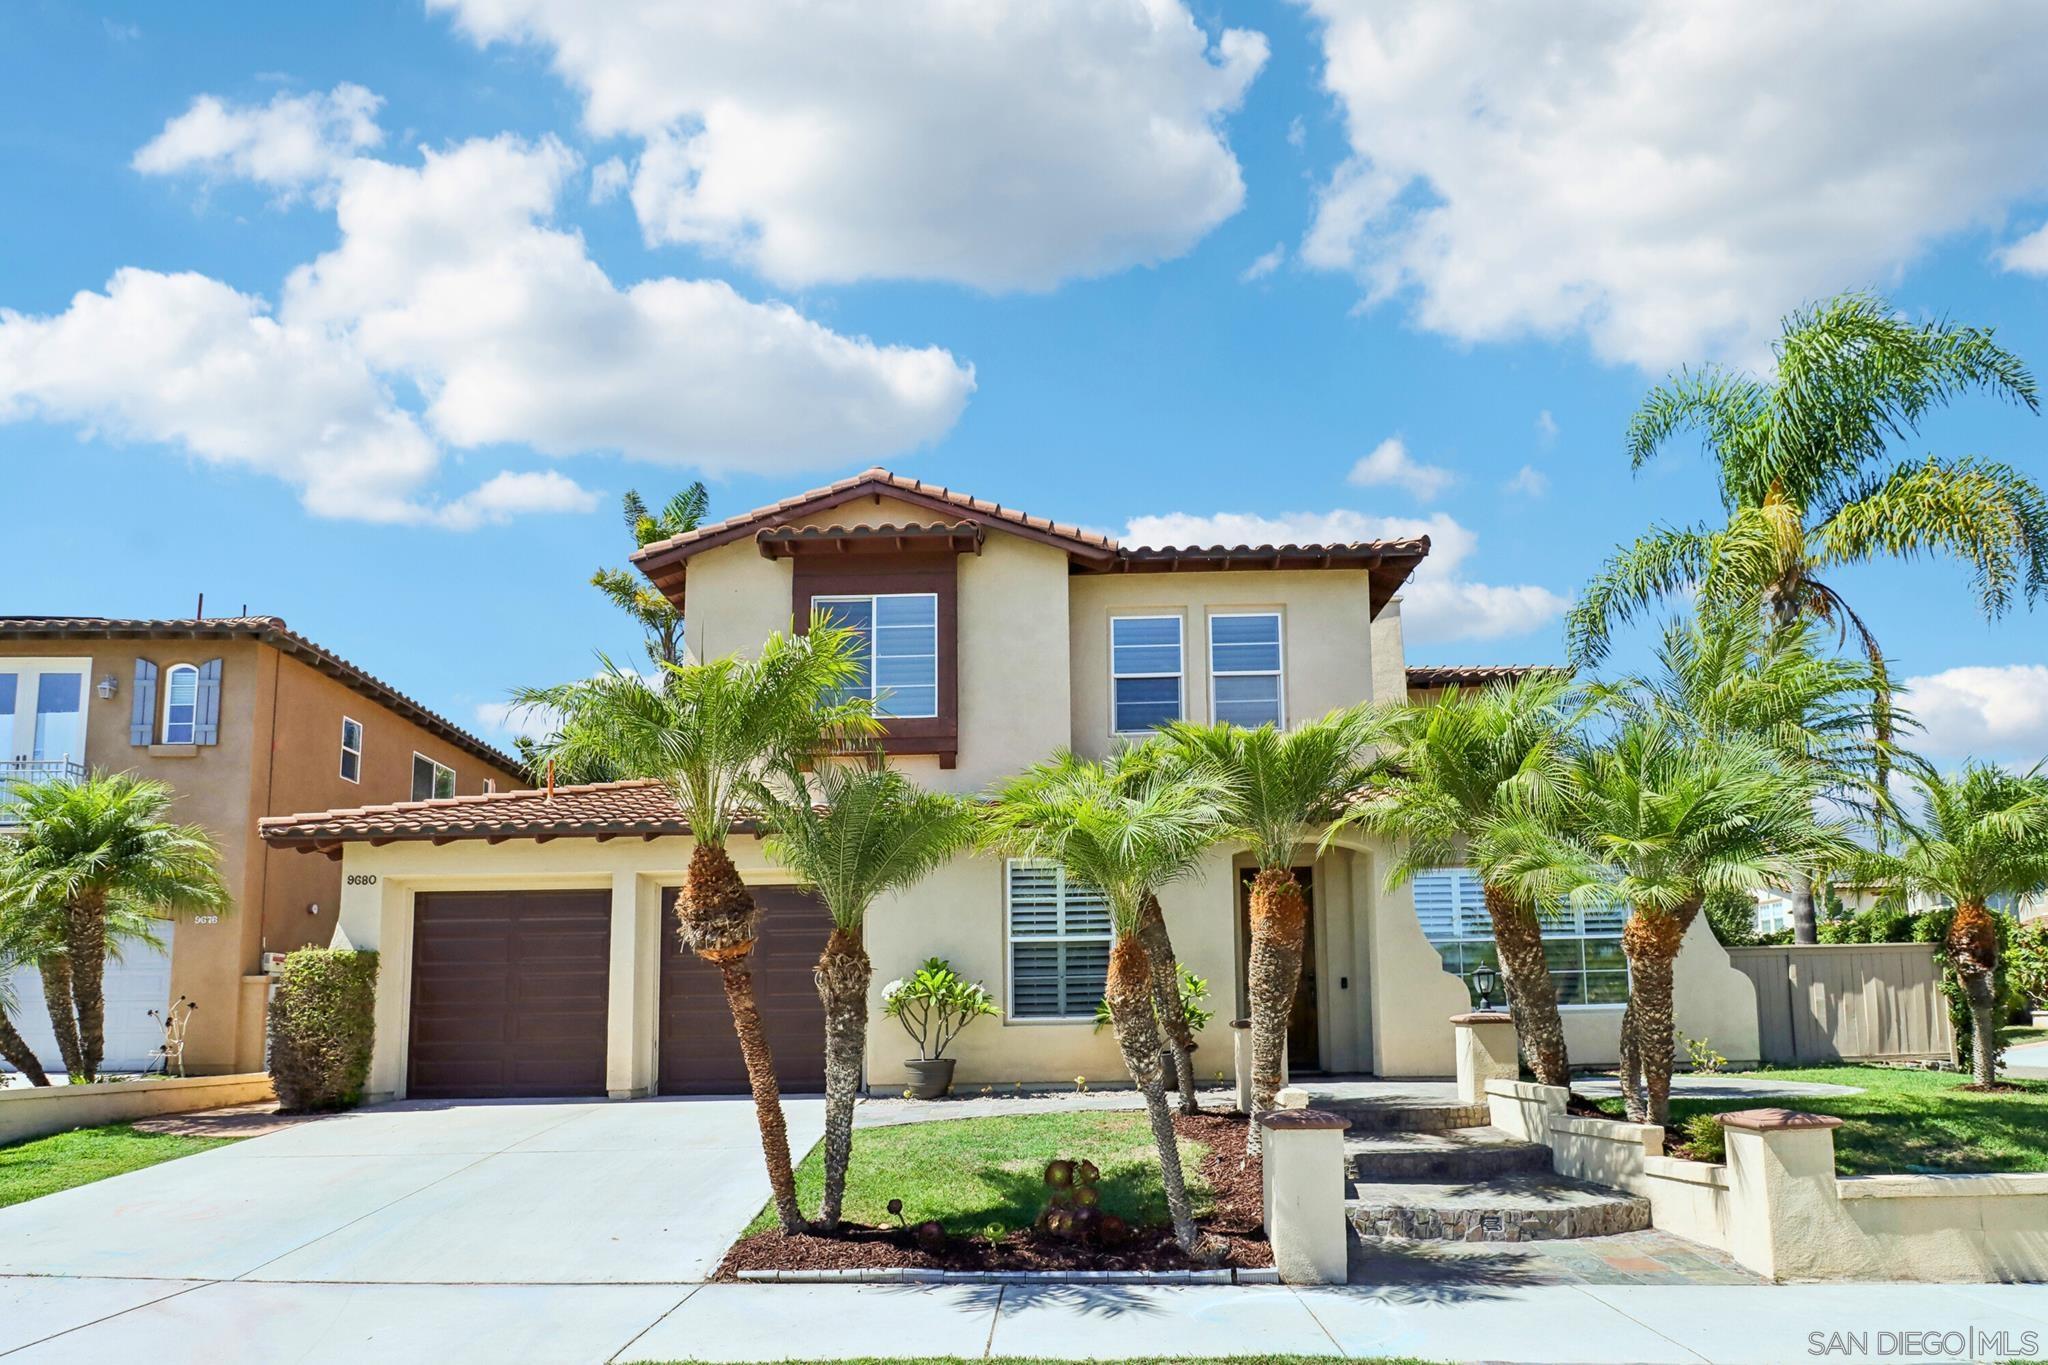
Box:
406, 890, 612, 1099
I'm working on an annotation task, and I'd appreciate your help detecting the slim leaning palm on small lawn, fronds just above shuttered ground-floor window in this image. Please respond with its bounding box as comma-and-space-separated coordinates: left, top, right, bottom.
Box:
983, 753, 1225, 1254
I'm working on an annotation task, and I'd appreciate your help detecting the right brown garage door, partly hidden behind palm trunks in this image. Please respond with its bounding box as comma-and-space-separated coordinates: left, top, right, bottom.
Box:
662, 886, 831, 1095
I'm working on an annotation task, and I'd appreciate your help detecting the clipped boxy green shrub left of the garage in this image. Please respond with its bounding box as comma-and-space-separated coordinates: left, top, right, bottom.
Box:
270, 948, 377, 1109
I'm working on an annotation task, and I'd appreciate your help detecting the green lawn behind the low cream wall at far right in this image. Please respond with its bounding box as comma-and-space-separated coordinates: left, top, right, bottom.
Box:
1599, 1066, 2048, 1175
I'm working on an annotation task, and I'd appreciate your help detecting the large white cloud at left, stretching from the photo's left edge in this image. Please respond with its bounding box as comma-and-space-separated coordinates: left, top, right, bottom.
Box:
0, 111, 975, 530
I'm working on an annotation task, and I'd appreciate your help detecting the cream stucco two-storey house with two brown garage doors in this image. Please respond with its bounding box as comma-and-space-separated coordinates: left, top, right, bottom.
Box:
264, 469, 1757, 1097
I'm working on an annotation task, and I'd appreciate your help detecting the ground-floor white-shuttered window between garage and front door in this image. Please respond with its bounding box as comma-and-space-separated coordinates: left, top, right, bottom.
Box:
1004, 857, 1114, 1019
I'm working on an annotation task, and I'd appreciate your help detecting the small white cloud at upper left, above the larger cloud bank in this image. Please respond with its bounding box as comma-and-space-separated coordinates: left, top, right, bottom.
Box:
133, 84, 383, 190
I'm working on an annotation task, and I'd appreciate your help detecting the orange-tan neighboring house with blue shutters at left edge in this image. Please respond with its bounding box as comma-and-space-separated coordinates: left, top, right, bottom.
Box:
0, 616, 522, 1072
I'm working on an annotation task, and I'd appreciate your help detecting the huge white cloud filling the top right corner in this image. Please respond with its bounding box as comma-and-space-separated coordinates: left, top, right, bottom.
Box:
1300, 0, 2048, 368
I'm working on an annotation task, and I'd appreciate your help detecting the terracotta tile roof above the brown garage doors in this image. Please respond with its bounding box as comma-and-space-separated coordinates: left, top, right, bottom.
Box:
256, 778, 690, 851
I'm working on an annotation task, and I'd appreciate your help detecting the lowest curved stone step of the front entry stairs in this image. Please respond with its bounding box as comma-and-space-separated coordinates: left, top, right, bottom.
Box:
1346, 1175, 1651, 1242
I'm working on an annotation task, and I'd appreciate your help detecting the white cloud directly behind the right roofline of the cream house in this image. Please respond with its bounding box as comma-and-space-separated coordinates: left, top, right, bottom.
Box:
1122, 510, 1571, 645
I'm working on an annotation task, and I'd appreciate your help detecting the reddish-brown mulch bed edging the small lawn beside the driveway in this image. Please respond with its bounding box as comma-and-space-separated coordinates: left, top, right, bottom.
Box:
713, 1113, 1274, 1281
